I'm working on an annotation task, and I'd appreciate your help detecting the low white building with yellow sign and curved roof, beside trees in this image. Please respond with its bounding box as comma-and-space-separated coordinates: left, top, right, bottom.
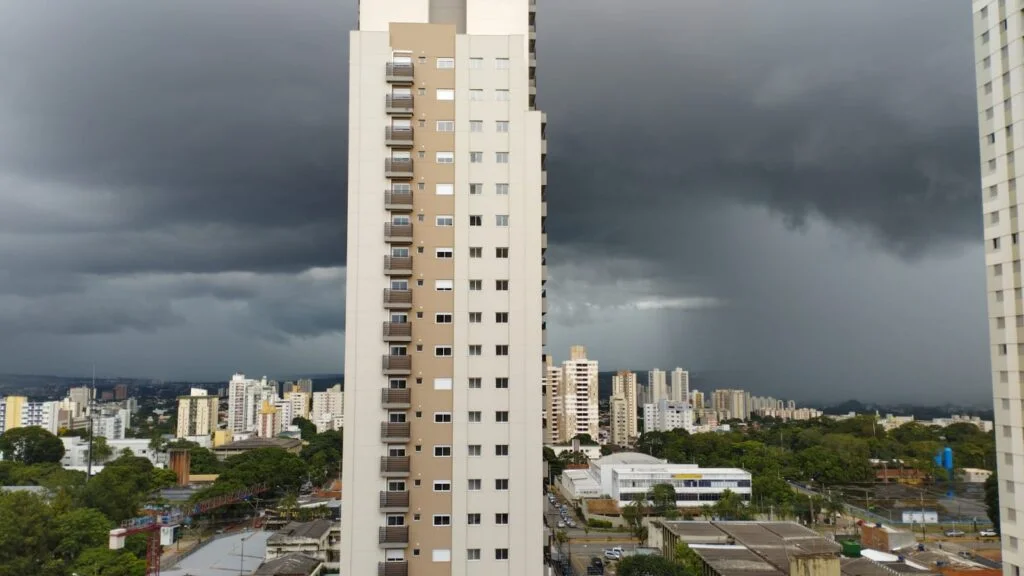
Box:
559, 452, 752, 507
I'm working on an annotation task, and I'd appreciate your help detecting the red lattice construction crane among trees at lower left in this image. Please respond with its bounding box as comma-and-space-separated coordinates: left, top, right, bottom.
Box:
110, 484, 268, 576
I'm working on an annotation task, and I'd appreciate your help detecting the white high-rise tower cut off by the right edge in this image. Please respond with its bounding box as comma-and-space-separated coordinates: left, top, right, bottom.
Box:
972, 0, 1024, 576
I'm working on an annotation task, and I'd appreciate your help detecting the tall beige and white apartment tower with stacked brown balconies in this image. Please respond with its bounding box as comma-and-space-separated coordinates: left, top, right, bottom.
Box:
341, 0, 548, 576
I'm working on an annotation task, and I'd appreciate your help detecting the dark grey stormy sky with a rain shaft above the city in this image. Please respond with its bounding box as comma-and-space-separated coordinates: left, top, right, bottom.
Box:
0, 0, 990, 404
